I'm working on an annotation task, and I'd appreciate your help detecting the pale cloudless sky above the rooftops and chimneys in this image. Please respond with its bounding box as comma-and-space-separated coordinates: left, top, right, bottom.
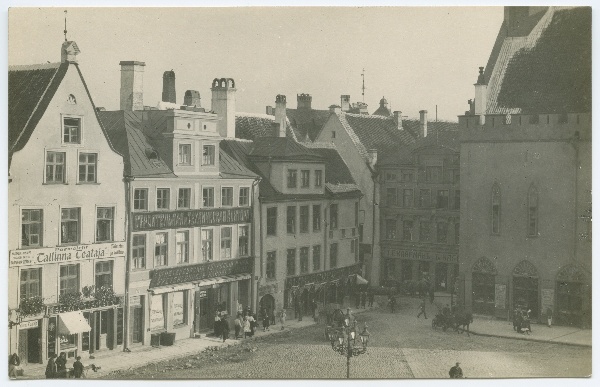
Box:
8, 7, 503, 121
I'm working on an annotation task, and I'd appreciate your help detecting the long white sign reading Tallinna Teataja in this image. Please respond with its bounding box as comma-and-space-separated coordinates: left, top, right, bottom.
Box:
9, 242, 125, 267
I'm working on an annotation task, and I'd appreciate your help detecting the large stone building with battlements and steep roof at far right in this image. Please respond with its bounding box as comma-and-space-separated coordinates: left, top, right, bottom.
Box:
459, 7, 592, 326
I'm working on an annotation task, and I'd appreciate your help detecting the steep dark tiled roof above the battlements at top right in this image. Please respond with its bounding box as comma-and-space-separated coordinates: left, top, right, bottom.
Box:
486, 7, 592, 114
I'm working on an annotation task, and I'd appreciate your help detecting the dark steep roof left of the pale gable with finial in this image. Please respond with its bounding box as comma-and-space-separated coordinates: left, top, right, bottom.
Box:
8, 63, 69, 160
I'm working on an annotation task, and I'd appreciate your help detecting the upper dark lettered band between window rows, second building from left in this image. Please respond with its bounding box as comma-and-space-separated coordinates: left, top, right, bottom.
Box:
133, 207, 250, 231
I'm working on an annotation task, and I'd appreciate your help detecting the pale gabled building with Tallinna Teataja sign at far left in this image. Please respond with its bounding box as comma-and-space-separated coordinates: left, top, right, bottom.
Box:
8, 41, 126, 366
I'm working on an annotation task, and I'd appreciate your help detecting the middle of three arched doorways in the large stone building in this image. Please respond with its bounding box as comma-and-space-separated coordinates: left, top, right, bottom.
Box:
512, 260, 539, 318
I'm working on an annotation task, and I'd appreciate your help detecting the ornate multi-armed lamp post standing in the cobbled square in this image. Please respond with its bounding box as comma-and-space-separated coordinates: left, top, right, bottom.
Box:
329, 309, 370, 379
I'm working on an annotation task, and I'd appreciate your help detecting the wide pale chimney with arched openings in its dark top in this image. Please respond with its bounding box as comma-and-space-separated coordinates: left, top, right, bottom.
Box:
210, 78, 236, 138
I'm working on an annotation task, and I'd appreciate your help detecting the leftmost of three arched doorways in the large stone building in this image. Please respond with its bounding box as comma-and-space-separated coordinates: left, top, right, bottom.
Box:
472, 257, 497, 315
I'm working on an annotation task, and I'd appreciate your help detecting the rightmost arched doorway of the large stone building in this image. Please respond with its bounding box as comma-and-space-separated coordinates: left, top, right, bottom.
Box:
554, 265, 589, 326
